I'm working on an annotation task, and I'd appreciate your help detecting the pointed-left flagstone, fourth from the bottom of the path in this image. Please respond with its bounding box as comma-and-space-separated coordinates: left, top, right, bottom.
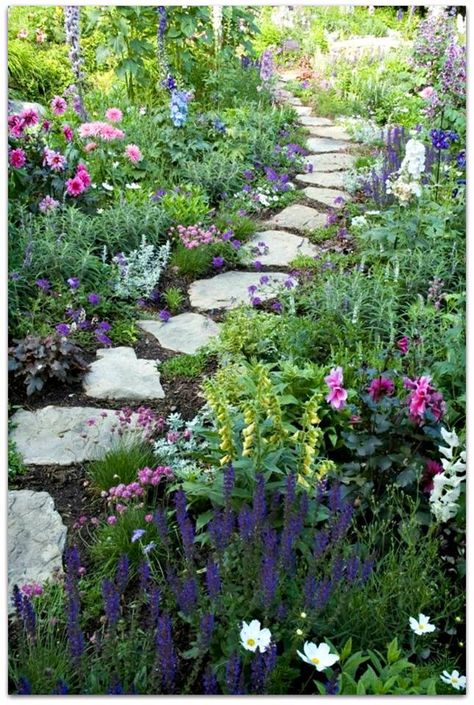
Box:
138, 313, 220, 355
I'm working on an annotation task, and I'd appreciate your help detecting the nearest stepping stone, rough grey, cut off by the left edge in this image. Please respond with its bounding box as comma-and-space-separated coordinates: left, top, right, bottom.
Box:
8, 490, 67, 612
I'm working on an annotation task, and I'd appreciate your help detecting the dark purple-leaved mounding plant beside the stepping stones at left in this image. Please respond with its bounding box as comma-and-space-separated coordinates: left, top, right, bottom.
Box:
8, 334, 88, 396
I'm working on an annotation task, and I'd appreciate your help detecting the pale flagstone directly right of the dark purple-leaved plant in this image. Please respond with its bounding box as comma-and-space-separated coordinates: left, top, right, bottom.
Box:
82, 347, 165, 401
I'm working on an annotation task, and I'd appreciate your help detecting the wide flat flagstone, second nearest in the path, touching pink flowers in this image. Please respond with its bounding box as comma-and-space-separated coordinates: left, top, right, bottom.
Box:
11, 406, 151, 465
